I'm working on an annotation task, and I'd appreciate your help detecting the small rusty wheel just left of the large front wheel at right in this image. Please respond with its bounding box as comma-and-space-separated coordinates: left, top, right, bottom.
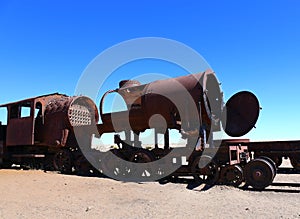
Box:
221, 165, 244, 187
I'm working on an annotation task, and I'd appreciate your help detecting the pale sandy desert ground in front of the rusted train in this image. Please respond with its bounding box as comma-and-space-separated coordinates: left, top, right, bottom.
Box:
0, 159, 300, 218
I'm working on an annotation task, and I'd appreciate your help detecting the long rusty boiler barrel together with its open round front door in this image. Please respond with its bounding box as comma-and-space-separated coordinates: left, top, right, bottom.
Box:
99, 70, 260, 141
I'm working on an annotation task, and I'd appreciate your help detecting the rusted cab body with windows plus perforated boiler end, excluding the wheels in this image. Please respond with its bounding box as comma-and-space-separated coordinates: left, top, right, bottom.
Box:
0, 93, 98, 147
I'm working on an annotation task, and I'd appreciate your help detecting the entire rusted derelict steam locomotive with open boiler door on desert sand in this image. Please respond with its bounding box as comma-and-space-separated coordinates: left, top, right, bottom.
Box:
0, 70, 300, 189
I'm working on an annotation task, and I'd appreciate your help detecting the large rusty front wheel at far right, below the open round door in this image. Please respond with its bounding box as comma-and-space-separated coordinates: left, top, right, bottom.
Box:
244, 158, 275, 190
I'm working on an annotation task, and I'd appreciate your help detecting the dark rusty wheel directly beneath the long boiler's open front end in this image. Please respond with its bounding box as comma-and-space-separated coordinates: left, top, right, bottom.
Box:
191, 155, 220, 185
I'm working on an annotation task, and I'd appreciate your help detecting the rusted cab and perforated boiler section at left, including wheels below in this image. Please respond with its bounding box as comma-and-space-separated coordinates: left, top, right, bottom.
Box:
0, 93, 98, 173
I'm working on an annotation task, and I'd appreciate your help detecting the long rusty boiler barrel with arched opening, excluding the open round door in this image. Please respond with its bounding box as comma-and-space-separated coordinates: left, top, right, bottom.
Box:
98, 70, 222, 135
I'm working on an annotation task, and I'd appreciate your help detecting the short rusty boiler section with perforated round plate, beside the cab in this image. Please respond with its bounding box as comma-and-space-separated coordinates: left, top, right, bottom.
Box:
40, 96, 99, 147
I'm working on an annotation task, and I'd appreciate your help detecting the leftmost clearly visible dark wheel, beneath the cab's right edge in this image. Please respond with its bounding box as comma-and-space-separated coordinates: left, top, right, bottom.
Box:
53, 149, 73, 174
